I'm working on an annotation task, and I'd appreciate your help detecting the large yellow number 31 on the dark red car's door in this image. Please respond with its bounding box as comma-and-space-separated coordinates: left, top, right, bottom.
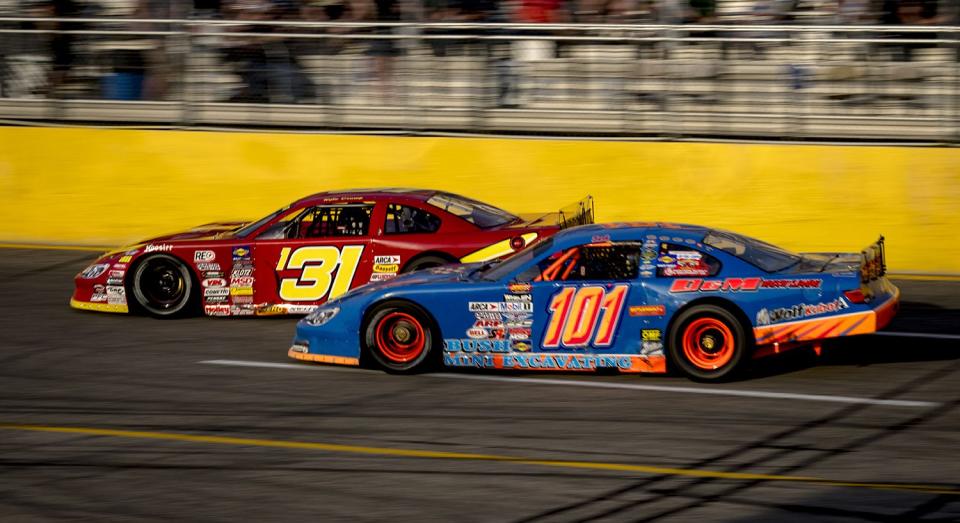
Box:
277, 245, 363, 301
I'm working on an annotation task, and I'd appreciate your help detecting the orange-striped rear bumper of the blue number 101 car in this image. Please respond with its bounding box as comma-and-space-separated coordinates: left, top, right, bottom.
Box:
753, 283, 900, 352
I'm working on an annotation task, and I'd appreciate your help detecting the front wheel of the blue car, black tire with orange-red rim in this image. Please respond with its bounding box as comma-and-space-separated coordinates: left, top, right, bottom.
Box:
362, 300, 443, 374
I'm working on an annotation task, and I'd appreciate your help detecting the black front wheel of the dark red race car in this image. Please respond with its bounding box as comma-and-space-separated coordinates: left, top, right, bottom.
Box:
128, 254, 198, 318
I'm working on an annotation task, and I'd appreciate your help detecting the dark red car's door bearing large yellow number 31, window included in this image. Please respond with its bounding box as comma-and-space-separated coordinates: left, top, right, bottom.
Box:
253, 202, 374, 313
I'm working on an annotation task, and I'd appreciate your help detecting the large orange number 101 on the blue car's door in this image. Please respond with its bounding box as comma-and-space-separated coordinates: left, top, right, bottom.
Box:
543, 285, 629, 349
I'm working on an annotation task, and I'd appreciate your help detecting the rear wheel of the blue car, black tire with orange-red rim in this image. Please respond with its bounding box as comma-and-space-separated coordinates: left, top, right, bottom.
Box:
668, 305, 753, 382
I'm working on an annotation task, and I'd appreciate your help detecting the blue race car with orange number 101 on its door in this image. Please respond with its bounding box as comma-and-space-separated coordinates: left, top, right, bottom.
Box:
288, 223, 900, 380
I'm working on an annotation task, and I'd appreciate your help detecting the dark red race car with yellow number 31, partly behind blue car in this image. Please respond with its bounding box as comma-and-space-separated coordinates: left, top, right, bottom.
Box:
70, 189, 593, 317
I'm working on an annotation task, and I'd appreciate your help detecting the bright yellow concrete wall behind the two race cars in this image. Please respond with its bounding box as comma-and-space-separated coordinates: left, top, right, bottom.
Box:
0, 128, 960, 273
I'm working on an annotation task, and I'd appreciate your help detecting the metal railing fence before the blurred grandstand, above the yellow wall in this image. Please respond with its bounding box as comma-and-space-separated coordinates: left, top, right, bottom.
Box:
0, 18, 960, 142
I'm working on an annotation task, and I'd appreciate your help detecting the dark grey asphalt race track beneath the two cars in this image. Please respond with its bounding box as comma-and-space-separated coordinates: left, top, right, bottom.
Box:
0, 249, 960, 522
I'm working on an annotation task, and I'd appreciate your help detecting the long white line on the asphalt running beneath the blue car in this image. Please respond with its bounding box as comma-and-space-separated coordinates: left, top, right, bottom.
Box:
197, 360, 940, 408
